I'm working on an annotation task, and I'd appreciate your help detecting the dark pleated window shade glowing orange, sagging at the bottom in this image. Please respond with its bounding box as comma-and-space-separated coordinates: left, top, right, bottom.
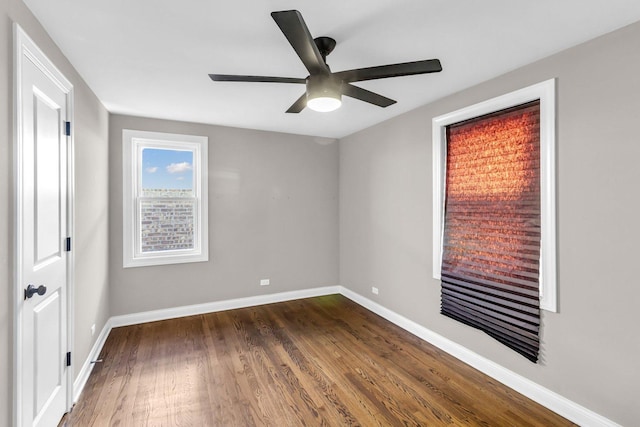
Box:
441, 101, 540, 362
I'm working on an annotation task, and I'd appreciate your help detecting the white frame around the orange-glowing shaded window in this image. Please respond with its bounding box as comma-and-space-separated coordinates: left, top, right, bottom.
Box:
432, 79, 557, 312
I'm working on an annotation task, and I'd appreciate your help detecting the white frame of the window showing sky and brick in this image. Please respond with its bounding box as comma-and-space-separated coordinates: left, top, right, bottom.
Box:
122, 129, 209, 268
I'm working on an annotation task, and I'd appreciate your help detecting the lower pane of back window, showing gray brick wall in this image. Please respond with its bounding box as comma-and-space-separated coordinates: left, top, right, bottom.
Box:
140, 200, 196, 253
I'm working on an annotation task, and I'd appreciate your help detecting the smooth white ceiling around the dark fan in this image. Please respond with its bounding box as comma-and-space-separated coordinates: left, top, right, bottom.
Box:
24, 0, 640, 138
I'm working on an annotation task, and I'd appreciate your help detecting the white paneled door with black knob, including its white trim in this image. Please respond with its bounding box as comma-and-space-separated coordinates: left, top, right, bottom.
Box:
15, 27, 71, 427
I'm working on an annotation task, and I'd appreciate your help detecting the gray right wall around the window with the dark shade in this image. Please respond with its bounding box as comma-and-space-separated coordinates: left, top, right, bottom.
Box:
340, 19, 640, 425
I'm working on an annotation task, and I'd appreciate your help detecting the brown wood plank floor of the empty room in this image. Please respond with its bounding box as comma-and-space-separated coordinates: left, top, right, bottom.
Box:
60, 295, 573, 427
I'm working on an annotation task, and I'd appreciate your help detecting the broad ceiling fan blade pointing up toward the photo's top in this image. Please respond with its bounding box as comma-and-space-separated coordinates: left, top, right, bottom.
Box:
271, 10, 330, 75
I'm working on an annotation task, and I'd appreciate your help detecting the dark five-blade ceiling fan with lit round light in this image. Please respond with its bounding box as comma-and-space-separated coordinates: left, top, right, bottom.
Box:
209, 10, 442, 113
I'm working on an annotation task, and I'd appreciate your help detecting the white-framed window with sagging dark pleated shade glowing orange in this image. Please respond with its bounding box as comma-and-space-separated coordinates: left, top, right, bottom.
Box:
433, 80, 556, 361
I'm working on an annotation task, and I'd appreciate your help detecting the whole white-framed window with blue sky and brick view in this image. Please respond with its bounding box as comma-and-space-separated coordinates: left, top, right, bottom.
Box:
122, 129, 208, 267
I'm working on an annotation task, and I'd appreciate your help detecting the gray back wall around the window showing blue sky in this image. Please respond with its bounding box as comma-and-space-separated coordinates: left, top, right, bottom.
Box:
109, 115, 338, 315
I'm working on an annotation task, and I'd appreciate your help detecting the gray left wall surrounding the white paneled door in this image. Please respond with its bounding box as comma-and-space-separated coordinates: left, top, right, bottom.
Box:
0, 0, 109, 426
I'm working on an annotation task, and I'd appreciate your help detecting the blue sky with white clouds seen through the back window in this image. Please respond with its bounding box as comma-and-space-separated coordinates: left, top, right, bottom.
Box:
142, 148, 193, 190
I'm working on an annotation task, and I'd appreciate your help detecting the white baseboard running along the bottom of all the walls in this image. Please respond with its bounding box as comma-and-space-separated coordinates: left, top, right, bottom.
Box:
73, 286, 621, 427
